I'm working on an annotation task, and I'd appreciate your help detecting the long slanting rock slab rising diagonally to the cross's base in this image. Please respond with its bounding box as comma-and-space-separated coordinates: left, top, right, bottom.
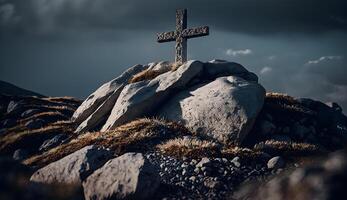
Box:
101, 61, 203, 131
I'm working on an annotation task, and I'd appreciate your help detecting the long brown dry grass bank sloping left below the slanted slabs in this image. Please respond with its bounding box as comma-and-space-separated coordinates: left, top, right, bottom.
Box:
24, 118, 191, 166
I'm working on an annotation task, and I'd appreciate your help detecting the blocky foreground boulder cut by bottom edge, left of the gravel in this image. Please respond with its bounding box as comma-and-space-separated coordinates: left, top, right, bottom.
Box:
83, 153, 160, 200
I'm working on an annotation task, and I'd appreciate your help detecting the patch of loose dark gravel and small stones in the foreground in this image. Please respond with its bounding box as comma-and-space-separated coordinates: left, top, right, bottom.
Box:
146, 152, 273, 199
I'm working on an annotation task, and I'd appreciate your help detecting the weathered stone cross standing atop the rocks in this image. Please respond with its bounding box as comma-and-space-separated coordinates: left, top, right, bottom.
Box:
157, 9, 209, 64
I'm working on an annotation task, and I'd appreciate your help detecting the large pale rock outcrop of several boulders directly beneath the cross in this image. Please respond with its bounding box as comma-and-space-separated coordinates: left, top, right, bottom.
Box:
72, 60, 265, 143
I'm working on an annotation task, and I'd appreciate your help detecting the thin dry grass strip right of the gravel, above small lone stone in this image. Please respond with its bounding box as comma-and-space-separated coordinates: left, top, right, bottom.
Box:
255, 140, 321, 156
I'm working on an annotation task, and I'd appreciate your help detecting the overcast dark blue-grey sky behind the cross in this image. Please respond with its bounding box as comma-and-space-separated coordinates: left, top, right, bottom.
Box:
0, 0, 347, 110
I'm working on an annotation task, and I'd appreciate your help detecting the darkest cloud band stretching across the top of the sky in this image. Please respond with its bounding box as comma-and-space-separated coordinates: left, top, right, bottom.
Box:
2, 0, 347, 34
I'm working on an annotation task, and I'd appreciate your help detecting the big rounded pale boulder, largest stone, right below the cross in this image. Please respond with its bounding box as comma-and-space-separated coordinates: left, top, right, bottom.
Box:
158, 76, 265, 143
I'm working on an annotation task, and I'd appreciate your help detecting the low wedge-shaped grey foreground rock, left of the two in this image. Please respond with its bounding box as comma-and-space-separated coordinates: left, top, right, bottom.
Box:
30, 145, 111, 184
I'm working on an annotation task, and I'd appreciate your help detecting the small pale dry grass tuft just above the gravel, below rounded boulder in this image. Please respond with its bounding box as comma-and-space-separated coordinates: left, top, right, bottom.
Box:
157, 137, 220, 158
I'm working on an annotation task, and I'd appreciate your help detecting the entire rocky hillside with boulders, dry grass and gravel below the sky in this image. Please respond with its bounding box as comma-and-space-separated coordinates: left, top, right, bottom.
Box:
0, 60, 347, 199
